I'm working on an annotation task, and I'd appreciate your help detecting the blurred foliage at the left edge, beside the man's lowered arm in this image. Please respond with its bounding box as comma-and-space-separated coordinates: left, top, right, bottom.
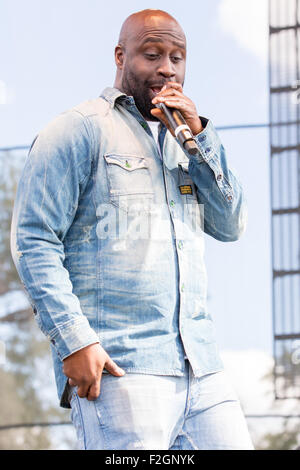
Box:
0, 152, 69, 450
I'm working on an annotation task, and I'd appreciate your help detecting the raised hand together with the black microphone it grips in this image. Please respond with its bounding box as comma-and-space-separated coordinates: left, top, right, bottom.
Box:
151, 82, 203, 155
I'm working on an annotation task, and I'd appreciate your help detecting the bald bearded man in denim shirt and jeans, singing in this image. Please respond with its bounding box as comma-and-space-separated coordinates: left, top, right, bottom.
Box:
12, 10, 252, 449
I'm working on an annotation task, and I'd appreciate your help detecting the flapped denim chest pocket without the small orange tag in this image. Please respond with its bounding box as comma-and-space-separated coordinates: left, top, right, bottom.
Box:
104, 154, 154, 211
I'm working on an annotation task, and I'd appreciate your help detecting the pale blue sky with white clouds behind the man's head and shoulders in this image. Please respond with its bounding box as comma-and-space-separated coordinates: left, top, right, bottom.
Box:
0, 0, 272, 353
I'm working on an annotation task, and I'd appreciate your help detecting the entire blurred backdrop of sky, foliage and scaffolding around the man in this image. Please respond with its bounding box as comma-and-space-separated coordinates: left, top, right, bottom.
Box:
0, 0, 300, 450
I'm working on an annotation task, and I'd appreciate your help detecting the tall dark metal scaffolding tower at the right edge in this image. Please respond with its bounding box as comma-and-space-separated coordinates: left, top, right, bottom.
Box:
269, 0, 300, 398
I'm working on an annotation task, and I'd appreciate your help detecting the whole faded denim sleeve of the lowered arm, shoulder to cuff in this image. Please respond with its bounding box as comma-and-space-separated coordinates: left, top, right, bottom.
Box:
11, 113, 98, 359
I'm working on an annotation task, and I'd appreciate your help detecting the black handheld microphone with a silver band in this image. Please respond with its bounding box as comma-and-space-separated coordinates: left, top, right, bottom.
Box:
155, 103, 199, 155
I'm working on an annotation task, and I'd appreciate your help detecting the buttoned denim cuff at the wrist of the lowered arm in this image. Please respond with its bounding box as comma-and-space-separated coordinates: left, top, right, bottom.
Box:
48, 315, 100, 360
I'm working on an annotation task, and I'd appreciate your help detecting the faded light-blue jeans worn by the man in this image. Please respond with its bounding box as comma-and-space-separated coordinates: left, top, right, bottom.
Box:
70, 361, 253, 450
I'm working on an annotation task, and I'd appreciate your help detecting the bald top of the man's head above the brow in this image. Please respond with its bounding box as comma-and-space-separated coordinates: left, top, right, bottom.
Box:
119, 9, 186, 48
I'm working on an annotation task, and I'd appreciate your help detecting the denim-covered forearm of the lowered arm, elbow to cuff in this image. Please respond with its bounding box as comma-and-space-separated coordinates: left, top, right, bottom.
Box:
11, 228, 99, 359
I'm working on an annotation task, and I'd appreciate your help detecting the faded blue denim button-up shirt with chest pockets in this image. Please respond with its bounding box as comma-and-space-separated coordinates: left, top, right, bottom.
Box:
11, 88, 246, 407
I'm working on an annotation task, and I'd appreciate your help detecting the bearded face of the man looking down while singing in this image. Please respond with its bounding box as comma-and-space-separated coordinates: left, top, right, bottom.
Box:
116, 17, 186, 121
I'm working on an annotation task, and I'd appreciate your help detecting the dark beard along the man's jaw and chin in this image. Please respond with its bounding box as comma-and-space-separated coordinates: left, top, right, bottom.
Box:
122, 70, 159, 121
